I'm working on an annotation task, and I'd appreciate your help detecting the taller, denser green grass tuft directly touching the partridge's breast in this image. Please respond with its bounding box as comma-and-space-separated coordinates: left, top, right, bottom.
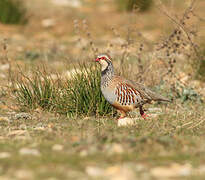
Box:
56, 65, 113, 116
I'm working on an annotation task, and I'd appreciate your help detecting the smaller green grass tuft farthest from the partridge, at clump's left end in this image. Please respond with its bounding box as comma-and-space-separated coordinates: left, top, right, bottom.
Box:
16, 72, 56, 110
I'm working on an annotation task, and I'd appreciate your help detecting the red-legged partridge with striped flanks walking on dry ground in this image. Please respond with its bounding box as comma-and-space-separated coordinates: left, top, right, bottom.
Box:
95, 54, 170, 119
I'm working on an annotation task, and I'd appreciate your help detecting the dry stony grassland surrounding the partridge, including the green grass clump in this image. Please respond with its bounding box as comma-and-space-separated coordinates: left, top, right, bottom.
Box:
0, 0, 205, 180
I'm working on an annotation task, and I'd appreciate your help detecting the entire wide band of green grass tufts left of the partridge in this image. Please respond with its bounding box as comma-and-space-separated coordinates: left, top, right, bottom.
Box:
15, 65, 113, 116
